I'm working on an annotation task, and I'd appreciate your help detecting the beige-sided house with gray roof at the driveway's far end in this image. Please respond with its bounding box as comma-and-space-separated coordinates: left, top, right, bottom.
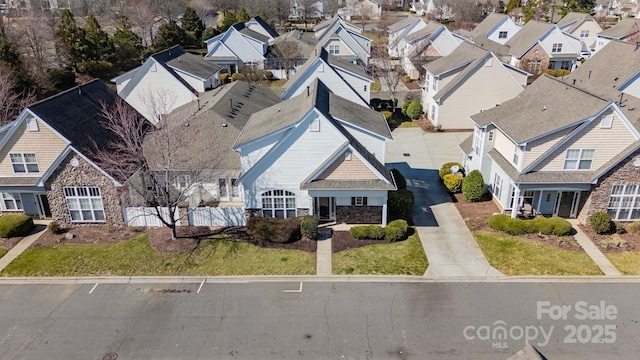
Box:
421, 42, 531, 130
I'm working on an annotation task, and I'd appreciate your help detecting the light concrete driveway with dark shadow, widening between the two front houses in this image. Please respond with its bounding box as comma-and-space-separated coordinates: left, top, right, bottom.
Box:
386, 128, 502, 278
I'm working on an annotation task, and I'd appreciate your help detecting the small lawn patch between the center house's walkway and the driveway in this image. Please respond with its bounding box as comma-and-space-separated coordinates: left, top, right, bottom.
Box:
332, 232, 429, 275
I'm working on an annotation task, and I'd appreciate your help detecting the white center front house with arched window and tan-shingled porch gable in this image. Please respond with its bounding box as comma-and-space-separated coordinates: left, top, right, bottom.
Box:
234, 79, 396, 225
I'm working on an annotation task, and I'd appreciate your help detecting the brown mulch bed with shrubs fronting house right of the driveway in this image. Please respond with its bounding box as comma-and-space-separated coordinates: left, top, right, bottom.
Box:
451, 194, 583, 251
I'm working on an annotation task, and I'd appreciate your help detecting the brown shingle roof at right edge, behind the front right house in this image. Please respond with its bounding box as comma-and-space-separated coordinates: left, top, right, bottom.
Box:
565, 40, 640, 129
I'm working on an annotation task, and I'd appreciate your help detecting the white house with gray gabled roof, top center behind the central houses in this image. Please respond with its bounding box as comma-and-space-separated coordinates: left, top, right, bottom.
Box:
314, 16, 371, 67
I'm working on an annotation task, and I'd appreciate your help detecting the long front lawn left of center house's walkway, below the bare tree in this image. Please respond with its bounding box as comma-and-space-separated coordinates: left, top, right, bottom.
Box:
2, 235, 316, 276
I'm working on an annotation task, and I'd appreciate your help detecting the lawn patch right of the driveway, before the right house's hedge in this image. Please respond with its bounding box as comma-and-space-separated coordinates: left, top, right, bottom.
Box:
473, 231, 602, 276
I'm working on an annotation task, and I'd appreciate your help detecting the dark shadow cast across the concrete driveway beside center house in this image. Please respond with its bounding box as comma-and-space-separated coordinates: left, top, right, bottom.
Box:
386, 162, 452, 227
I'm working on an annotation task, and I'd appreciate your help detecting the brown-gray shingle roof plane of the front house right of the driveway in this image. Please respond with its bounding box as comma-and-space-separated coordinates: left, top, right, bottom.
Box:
471, 75, 609, 143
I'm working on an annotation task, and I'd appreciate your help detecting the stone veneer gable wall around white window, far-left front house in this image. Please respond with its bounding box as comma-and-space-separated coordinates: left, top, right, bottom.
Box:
45, 153, 124, 226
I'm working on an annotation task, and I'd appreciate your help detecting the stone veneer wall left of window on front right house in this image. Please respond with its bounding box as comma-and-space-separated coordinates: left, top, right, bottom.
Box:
578, 150, 640, 224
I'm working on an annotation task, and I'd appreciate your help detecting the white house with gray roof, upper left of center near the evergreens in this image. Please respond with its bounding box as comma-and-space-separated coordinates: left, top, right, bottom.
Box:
204, 23, 273, 74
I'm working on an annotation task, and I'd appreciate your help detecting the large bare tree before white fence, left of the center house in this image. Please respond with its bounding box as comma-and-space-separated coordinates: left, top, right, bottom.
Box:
93, 94, 210, 239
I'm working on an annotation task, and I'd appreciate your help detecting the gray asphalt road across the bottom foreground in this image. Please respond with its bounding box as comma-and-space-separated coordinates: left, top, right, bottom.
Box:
0, 282, 640, 360
